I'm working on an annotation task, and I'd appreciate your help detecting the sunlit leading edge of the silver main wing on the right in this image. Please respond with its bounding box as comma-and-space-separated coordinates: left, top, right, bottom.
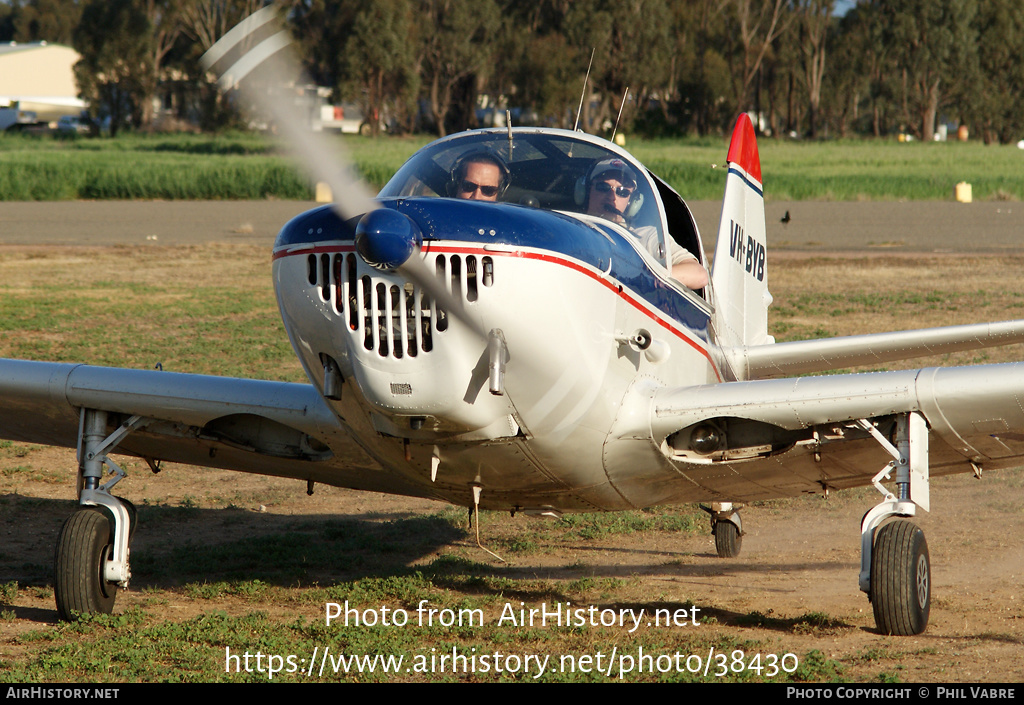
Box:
651, 363, 1024, 475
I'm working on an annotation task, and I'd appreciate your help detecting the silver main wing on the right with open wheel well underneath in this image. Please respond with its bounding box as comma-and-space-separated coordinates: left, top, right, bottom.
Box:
650, 363, 1024, 501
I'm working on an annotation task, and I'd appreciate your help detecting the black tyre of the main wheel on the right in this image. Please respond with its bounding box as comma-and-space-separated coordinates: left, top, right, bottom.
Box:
870, 520, 932, 636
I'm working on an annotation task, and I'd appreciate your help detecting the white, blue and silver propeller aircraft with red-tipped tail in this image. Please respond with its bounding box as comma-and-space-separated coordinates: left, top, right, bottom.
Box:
6, 8, 1024, 634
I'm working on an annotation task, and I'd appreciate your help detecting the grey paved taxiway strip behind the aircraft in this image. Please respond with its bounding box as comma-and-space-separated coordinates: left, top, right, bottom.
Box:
0, 201, 1024, 254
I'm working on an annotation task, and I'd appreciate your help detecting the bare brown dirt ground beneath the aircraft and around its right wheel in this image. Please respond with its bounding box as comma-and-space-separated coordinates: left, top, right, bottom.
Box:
0, 449, 1024, 682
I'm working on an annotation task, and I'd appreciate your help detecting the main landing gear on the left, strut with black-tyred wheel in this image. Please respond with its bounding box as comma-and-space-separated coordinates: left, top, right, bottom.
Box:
53, 409, 145, 620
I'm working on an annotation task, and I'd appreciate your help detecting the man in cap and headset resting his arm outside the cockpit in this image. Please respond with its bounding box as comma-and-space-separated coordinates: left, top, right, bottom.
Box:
587, 159, 708, 289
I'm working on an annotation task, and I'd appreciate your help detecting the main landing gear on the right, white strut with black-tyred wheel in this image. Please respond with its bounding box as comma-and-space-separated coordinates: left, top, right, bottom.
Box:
857, 412, 932, 636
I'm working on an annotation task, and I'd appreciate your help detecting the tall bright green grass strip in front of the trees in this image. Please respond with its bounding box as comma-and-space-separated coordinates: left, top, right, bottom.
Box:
6, 133, 1024, 201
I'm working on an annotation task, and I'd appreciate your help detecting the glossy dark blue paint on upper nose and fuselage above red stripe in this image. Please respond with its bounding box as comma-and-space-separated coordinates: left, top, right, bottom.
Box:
274, 198, 709, 342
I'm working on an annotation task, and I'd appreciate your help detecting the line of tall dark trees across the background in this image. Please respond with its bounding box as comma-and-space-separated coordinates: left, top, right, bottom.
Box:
6, 0, 1024, 142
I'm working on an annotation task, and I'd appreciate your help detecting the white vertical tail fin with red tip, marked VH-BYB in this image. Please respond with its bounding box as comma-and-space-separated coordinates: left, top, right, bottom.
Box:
712, 113, 774, 346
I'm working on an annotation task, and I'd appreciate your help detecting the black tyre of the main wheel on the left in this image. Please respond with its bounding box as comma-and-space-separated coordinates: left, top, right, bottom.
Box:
53, 509, 118, 621
